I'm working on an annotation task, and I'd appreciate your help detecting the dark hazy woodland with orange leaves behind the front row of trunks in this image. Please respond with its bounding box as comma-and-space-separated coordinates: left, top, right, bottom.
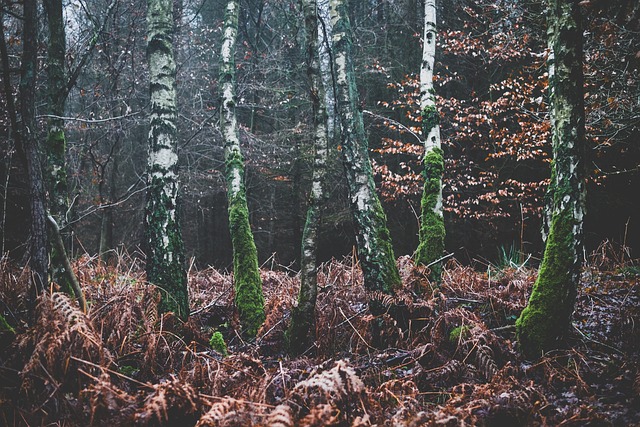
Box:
0, 0, 640, 269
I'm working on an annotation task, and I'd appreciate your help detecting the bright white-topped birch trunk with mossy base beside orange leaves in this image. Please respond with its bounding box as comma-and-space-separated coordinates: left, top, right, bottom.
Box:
415, 0, 445, 283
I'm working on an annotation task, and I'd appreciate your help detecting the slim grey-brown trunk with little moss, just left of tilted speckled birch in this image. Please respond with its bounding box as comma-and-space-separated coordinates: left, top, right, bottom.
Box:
289, 0, 328, 353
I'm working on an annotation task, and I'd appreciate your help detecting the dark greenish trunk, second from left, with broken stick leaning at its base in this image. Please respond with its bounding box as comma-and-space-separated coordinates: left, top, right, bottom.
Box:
44, 0, 73, 295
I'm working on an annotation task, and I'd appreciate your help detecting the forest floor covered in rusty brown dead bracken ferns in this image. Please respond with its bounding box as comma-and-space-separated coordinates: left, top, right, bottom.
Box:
0, 245, 640, 427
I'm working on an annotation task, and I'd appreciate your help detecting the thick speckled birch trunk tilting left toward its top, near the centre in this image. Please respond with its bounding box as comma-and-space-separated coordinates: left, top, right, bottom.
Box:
330, 0, 400, 313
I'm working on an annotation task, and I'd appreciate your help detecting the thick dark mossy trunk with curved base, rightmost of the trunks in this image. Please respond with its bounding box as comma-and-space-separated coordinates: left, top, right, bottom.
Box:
516, 0, 586, 358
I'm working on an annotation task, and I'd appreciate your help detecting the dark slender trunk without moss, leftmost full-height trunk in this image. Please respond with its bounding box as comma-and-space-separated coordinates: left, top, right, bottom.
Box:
18, 0, 48, 301
